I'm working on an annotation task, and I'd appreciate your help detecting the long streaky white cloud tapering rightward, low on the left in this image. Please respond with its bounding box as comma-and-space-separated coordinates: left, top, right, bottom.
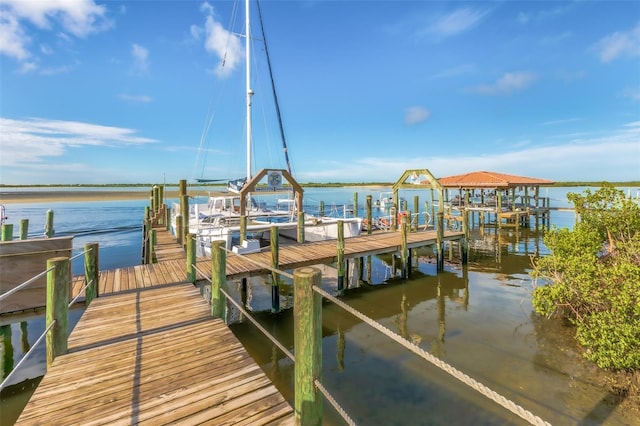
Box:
0, 118, 156, 167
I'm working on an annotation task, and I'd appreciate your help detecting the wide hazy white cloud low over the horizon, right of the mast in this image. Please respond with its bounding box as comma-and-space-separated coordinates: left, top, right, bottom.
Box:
298, 121, 640, 182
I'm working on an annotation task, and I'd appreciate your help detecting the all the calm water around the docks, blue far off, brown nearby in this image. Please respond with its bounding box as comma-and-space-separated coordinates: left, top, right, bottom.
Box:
0, 188, 637, 425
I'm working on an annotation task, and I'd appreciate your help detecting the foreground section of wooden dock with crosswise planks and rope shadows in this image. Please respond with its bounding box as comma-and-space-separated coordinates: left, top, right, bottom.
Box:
16, 282, 293, 425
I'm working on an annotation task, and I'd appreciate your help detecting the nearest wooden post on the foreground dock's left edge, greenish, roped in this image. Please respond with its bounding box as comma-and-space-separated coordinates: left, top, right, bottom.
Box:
45, 257, 71, 367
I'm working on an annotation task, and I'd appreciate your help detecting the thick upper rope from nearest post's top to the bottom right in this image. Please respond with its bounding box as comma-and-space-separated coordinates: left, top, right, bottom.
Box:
313, 286, 550, 426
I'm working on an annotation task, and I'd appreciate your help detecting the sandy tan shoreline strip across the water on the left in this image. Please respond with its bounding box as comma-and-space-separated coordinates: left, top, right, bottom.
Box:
0, 189, 185, 204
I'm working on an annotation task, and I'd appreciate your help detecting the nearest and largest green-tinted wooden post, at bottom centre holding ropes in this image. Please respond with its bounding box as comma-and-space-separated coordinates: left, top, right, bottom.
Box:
293, 267, 322, 426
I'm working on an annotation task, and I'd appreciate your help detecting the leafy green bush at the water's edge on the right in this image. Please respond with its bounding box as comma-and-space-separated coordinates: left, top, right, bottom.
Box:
531, 185, 640, 371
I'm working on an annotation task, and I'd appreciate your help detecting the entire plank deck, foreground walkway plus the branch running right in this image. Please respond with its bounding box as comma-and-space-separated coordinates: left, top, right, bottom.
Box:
16, 225, 463, 425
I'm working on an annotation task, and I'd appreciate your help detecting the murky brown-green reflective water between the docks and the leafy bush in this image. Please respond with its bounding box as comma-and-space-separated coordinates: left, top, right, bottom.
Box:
232, 230, 633, 424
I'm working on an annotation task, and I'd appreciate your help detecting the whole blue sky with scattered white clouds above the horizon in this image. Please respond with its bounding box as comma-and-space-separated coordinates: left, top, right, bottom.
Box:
0, 0, 640, 184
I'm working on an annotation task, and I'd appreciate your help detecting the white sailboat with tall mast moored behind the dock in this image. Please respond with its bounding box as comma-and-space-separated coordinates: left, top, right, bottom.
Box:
172, 0, 362, 255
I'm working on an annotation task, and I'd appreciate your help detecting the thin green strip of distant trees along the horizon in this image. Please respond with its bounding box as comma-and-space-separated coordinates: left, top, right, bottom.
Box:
0, 181, 640, 188
